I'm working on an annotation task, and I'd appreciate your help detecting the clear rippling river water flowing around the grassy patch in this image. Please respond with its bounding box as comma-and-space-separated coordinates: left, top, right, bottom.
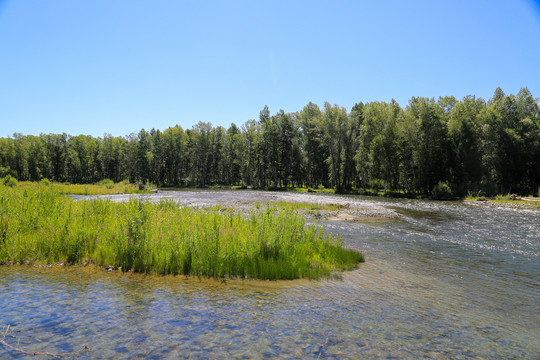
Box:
0, 191, 540, 359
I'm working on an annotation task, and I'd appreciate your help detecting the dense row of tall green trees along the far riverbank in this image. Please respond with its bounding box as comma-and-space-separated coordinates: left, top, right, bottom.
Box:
0, 88, 540, 196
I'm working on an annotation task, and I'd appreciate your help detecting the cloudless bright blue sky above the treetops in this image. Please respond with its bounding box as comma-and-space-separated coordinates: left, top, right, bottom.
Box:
0, 0, 540, 137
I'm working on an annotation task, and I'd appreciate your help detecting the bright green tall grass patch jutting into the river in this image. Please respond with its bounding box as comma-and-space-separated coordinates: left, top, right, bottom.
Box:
0, 185, 363, 279
